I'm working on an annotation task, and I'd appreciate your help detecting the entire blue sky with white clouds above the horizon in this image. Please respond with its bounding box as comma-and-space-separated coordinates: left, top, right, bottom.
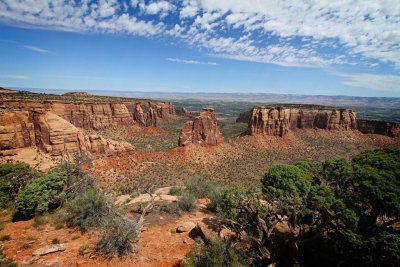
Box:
0, 0, 400, 97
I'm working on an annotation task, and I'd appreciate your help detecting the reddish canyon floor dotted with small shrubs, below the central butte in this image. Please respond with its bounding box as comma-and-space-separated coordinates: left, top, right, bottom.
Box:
88, 117, 400, 189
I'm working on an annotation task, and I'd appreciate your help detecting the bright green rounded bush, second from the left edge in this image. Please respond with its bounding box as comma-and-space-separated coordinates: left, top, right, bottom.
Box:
13, 172, 66, 221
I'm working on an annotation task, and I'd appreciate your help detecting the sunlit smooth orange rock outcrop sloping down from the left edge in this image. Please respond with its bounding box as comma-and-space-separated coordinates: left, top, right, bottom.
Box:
0, 110, 133, 156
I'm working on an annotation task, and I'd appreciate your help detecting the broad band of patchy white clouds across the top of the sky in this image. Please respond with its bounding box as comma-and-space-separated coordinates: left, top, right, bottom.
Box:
0, 0, 400, 70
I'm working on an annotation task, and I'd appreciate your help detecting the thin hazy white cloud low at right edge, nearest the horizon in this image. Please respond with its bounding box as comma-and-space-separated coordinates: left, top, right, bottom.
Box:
334, 72, 400, 92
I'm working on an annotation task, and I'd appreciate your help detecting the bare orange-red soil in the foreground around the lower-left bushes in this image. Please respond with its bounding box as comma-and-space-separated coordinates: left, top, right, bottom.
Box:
1, 204, 213, 267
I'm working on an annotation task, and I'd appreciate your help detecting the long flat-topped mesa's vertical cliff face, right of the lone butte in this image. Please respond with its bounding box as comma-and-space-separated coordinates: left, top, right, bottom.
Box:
247, 106, 357, 136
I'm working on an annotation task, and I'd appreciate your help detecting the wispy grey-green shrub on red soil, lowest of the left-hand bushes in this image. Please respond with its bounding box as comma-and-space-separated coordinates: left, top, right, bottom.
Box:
97, 216, 140, 256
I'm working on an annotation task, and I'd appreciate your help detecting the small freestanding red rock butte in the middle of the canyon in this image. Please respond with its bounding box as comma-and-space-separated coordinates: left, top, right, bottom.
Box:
178, 108, 224, 146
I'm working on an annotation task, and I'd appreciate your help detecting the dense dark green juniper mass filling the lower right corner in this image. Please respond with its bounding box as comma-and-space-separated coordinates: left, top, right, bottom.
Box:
186, 149, 400, 266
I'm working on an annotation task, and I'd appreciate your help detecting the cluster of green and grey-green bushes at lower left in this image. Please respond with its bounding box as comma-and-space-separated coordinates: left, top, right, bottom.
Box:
0, 162, 152, 258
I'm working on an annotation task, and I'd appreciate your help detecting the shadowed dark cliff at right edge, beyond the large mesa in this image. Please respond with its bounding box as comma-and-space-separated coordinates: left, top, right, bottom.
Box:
358, 120, 400, 138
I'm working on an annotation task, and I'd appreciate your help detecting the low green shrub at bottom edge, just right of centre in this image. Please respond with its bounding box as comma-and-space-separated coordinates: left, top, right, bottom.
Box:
184, 238, 251, 267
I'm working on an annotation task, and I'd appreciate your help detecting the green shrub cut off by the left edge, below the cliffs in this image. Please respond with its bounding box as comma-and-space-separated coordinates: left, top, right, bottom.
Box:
0, 162, 38, 208
